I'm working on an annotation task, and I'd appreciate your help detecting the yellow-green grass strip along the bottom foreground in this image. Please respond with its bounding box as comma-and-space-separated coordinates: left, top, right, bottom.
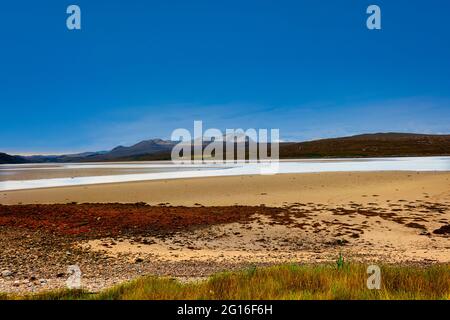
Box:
0, 257, 450, 300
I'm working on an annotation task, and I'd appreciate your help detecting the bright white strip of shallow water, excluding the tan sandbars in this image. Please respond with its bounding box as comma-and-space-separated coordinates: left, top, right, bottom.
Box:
0, 157, 450, 191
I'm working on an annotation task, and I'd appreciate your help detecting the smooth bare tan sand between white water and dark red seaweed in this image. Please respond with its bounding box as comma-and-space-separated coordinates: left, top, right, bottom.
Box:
0, 172, 450, 206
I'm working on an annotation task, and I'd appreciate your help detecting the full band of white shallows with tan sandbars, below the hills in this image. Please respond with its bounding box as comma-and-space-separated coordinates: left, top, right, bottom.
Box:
0, 157, 450, 191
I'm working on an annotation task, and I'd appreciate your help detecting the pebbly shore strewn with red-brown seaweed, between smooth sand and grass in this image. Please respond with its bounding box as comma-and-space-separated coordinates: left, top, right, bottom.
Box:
0, 202, 450, 293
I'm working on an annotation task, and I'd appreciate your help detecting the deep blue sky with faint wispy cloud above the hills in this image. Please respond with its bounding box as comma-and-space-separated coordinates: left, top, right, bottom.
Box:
0, 0, 450, 153
